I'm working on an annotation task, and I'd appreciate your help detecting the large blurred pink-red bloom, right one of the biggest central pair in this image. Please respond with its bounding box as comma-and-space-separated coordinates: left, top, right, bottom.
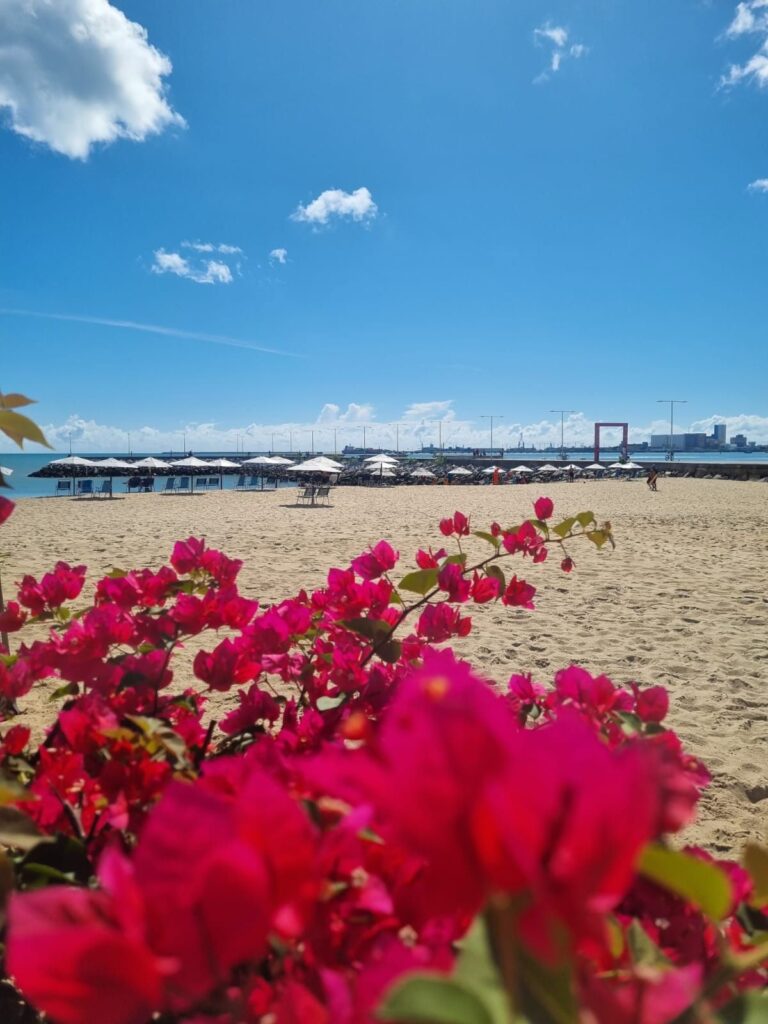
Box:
471, 713, 658, 956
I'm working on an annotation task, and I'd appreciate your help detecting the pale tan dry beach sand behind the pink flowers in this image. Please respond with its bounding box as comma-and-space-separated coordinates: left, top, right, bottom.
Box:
0, 478, 768, 852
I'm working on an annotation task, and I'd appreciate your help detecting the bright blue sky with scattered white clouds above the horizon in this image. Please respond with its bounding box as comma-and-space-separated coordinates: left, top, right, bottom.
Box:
0, 0, 768, 451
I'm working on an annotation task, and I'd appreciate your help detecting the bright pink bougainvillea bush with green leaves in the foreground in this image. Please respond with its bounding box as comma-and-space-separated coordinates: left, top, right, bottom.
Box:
0, 489, 768, 1024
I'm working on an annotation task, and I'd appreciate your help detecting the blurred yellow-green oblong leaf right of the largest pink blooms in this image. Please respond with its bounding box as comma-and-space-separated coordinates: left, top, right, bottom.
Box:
639, 843, 732, 921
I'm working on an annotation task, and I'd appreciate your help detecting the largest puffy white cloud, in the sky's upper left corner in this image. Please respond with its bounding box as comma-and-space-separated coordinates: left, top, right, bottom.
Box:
0, 0, 184, 160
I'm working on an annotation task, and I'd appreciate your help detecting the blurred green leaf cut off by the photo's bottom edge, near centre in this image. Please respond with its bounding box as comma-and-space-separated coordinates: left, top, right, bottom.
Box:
376, 974, 500, 1024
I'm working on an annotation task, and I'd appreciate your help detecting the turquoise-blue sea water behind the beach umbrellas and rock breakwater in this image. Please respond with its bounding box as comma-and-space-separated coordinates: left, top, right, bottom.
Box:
0, 451, 768, 500
